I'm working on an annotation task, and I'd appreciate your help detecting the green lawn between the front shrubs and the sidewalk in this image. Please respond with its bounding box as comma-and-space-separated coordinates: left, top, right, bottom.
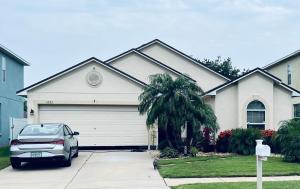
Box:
159, 156, 300, 177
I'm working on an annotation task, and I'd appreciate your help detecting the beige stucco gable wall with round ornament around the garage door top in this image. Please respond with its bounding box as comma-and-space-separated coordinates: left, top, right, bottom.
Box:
27, 63, 142, 123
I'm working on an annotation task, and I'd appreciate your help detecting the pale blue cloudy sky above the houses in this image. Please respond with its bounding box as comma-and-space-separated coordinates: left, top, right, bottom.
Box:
0, 0, 300, 86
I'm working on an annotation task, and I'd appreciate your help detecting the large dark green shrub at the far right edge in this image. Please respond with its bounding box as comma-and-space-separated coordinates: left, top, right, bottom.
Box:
275, 119, 300, 162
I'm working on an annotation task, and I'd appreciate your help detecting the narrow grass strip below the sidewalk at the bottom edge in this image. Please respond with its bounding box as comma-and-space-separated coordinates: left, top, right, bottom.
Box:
172, 181, 300, 189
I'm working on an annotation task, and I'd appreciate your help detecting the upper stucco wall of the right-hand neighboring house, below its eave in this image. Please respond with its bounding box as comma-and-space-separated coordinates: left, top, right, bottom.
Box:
267, 56, 300, 90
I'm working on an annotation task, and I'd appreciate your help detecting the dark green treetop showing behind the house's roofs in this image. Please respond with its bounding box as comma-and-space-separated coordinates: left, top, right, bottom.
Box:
196, 56, 249, 79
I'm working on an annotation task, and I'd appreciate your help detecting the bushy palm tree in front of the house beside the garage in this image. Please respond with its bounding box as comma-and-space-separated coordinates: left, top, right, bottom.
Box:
139, 74, 217, 147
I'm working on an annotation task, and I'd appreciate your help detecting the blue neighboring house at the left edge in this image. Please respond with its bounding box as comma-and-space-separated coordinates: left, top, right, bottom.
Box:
0, 45, 29, 147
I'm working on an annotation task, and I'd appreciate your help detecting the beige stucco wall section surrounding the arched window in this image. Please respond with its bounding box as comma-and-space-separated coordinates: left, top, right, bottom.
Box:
207, 73, 293, 130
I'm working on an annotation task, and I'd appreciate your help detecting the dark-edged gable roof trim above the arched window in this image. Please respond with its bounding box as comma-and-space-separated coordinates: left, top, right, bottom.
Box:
203, 68, 300, 96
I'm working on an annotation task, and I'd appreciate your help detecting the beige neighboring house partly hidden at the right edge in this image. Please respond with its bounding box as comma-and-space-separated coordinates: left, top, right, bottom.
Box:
263, 50, 300, 118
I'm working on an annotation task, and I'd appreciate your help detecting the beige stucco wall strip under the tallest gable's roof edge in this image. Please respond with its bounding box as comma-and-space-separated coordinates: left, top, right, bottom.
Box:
141, 44, 226, 91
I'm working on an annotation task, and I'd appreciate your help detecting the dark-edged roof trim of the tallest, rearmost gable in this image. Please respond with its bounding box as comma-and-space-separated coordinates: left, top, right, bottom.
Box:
137, 39, 230, 81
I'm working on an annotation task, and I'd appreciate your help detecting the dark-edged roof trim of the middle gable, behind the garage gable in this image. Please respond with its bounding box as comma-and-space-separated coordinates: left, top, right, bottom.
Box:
105, 48, 196, 82
